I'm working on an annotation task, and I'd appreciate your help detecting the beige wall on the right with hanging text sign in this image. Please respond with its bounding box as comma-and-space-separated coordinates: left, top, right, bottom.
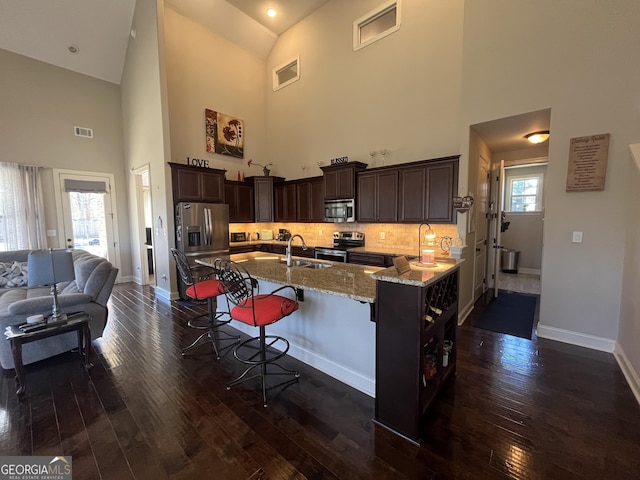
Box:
462, 0, 640, 348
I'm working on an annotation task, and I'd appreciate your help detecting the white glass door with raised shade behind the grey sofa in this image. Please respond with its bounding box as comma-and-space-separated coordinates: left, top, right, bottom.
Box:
54, 170, 120, 268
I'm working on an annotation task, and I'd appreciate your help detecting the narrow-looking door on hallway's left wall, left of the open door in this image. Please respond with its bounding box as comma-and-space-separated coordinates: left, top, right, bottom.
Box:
473, 154, 490, 302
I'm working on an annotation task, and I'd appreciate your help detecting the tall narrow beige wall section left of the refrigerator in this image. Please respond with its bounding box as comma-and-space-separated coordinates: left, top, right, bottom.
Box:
121, 0, 172, 298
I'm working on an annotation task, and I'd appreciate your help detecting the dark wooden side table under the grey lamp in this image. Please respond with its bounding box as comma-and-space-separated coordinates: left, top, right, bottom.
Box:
4, 313, 92, 395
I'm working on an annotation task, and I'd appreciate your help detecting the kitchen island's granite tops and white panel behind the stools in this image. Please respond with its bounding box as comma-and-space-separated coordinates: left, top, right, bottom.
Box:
197, 252, 457, 397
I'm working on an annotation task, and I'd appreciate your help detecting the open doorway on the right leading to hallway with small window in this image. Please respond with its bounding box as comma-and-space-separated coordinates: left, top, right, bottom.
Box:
467, 109, 551, 302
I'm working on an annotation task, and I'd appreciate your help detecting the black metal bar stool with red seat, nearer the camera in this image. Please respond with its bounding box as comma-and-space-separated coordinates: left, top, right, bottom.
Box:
215, 258, 300, 407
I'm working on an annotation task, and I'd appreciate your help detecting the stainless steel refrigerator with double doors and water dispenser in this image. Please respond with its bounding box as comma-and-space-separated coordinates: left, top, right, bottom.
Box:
175, 202, 229, 299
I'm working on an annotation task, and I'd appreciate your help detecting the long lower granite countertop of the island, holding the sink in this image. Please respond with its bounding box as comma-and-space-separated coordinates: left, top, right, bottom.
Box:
197, 253, 383, 303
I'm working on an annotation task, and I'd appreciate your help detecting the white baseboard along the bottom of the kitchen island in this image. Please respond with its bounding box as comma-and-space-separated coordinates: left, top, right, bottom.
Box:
231, 321, 376, 398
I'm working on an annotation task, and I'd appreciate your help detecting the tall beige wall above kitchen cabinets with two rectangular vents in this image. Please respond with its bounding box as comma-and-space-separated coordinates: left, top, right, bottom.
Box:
266, 0, 463, 178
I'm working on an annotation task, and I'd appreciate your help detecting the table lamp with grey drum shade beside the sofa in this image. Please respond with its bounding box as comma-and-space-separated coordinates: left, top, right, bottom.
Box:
27, 248, 76, 321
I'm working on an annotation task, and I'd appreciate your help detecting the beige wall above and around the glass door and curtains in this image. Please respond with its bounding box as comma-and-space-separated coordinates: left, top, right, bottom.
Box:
0, 50, 131, 279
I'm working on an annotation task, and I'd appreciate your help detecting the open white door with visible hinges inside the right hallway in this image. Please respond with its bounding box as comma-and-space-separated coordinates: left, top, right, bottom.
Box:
487, 160, 504, 297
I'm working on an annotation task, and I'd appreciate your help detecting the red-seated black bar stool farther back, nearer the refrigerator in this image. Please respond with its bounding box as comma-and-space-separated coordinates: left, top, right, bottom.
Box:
171, 248, 240, 359
